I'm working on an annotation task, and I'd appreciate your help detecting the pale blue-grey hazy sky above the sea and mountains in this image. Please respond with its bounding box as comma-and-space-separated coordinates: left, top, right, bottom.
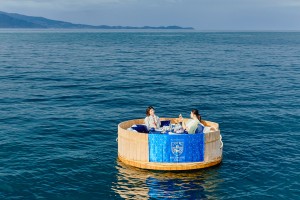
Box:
0, 0, 300, 31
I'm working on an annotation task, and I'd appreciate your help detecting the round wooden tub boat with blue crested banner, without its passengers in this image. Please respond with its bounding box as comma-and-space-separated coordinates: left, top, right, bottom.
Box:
118, 118, 223, 171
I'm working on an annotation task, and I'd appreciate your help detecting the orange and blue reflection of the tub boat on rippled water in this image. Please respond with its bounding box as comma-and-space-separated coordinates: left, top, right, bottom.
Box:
112, 161, 222, 199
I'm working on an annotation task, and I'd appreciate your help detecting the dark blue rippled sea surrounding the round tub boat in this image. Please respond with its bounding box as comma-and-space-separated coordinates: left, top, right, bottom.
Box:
0, 30, 300, 200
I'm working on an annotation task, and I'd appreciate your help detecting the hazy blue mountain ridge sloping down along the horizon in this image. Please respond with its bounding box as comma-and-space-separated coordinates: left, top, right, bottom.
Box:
0, 11, 193, 29
